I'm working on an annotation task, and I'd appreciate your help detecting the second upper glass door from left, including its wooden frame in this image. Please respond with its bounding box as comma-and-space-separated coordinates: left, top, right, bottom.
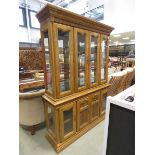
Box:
74, 28, 88, 91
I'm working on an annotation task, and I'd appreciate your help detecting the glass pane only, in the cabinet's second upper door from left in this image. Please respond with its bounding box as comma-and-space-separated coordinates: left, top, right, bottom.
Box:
78, 33, 86, 87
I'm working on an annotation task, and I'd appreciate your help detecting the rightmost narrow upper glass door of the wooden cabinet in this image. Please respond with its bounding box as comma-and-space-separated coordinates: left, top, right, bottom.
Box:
100, 35, 108, 83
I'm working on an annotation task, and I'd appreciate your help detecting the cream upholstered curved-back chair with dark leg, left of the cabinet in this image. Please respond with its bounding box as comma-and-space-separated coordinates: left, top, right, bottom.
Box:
19, 89, 45, 135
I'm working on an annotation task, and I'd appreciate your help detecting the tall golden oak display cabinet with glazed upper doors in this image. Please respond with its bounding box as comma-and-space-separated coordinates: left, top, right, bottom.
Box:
37, 4, 113, 152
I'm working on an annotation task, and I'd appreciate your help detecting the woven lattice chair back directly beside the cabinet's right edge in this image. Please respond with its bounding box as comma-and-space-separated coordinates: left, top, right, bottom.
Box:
108, 75, 124, 96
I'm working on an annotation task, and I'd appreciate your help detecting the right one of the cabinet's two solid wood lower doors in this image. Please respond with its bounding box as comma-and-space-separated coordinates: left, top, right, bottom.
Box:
90, 92, 100, 121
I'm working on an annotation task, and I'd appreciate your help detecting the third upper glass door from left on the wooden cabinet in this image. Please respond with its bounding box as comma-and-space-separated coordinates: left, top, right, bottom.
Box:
89, 32, 100, 86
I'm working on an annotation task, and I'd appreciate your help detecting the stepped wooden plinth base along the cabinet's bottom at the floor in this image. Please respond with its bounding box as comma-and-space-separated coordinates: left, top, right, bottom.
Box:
46, 114, 105, 153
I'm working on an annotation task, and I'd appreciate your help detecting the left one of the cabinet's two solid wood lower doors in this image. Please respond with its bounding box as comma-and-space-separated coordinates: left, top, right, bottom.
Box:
77, 97, 90, 130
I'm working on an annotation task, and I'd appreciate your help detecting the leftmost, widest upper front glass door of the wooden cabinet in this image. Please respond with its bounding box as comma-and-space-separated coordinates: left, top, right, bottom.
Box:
54, 23, 73, 98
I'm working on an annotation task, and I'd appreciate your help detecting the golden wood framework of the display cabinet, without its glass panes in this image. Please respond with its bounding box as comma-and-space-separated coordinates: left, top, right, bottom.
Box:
37, 5, 113, 152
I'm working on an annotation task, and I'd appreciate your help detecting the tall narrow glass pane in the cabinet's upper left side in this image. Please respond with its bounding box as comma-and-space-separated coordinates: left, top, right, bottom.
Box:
44, 31, 52, 92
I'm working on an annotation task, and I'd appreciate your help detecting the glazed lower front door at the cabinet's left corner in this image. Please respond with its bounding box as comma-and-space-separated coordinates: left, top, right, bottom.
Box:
60, 102, 76, 141
